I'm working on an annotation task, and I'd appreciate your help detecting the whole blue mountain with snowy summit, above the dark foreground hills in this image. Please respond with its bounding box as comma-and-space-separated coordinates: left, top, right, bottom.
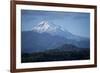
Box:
21, 21, 90, 53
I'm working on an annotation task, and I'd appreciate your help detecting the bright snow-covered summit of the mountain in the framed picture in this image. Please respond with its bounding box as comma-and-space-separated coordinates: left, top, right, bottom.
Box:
33, 21, 61, 33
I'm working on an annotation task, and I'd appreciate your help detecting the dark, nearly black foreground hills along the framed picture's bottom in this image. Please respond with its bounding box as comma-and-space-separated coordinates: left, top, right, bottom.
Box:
21, 44, 90, 63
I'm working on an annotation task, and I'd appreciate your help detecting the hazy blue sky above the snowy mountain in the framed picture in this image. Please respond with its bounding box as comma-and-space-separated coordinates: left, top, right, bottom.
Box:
21, 10, 90, 37
